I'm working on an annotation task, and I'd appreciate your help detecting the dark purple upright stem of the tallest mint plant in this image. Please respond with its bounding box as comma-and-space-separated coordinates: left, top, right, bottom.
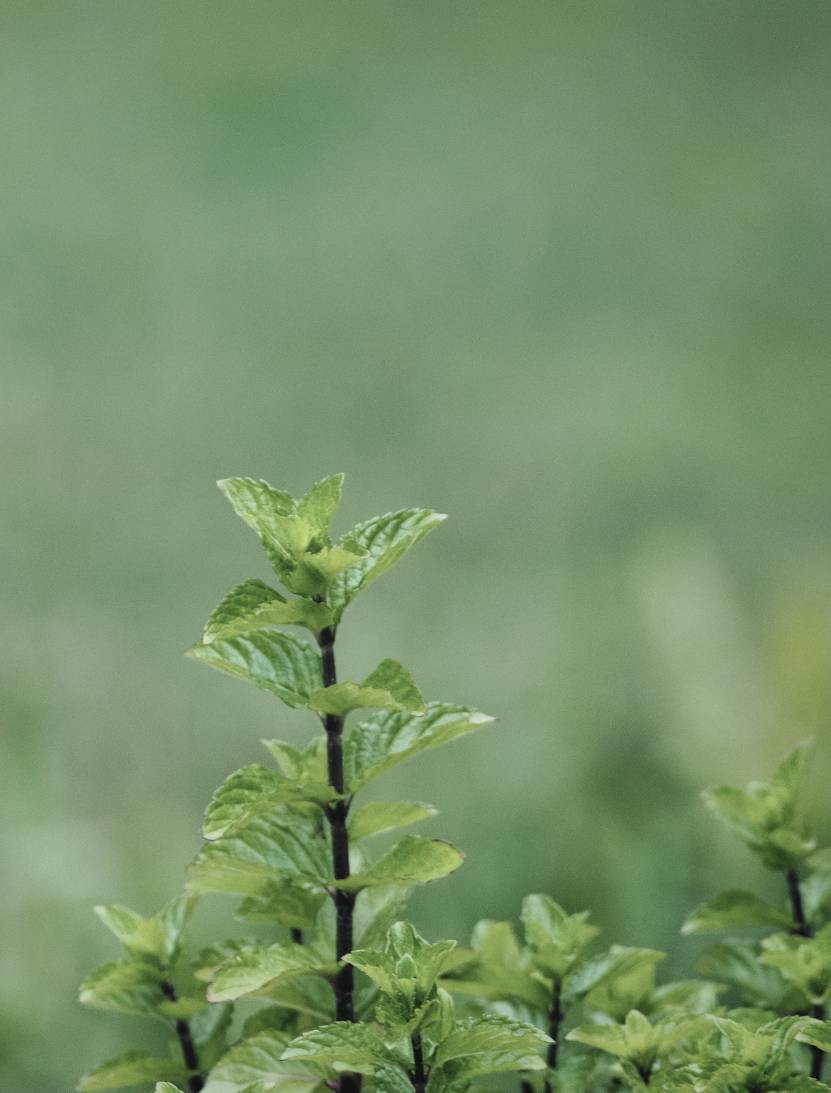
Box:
317, 626, 361, 1093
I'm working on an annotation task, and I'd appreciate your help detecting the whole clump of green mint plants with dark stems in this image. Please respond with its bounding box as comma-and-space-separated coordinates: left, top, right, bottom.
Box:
78, 475, 831, 1093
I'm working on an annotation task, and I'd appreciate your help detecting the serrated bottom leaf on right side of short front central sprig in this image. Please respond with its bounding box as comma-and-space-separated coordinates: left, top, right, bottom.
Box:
428, 1015, 551, 1090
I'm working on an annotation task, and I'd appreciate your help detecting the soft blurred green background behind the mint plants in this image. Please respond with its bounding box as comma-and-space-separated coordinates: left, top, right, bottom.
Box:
0, 0, 831, 1093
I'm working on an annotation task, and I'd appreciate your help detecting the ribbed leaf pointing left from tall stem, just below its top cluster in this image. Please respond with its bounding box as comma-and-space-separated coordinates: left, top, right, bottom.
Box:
188, 630, 320, 708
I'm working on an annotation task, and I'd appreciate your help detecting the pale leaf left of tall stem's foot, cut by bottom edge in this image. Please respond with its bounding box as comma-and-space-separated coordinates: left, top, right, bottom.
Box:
204, 1029, 321, 1093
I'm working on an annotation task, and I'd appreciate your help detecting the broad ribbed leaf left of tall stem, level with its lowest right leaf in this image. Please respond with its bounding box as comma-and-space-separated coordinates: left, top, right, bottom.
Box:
187, 815, 331, 896
